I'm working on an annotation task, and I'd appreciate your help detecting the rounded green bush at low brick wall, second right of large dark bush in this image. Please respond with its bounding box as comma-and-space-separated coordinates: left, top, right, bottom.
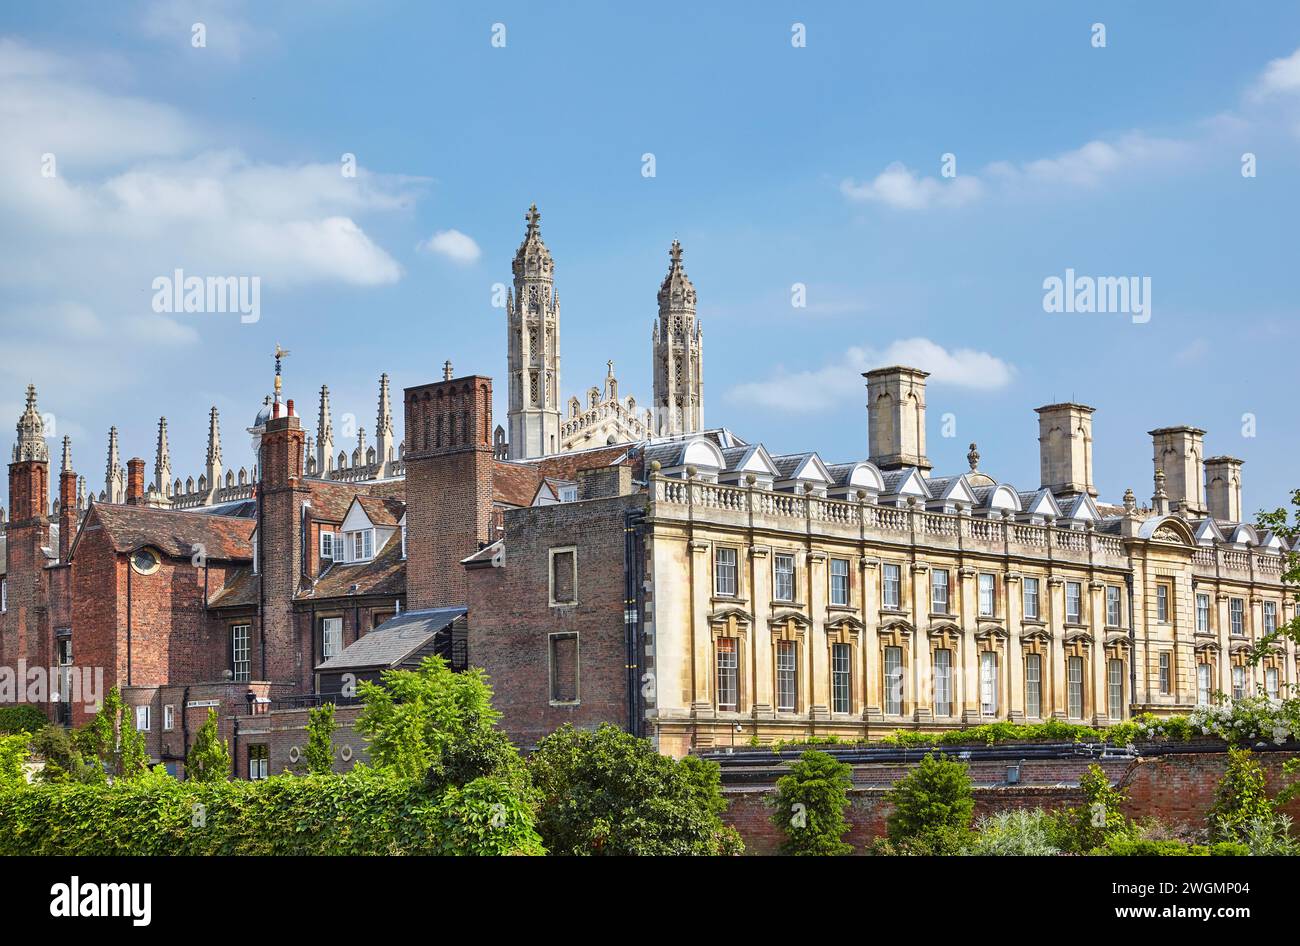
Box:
885, 752, 975, 854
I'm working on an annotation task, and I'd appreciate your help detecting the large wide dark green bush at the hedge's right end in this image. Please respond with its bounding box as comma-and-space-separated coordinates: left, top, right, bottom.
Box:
528, 724, 741, 855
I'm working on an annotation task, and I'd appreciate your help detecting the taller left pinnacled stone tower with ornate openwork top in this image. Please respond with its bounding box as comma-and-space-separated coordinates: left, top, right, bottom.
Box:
506, 204, 560, 460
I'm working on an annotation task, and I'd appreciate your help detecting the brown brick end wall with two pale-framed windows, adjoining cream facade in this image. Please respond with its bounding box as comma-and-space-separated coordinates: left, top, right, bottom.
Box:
467, 495, 645, 746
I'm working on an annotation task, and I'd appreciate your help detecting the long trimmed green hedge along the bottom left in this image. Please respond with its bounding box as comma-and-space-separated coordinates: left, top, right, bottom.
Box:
0, 765, 545, 856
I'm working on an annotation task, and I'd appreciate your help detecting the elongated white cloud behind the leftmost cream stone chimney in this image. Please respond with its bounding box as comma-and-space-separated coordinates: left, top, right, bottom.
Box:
727, 338, 1015, 413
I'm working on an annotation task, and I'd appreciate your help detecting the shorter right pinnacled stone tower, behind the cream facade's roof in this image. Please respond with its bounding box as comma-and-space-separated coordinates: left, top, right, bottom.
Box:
654, 240, 705, 437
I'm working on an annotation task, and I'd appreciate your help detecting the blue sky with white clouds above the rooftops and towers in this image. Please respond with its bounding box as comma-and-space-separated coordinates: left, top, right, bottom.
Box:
0, 1, 1300, 511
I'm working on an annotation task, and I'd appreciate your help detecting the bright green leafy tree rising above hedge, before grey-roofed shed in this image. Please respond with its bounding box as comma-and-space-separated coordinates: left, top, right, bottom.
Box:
356, 656, 501, 778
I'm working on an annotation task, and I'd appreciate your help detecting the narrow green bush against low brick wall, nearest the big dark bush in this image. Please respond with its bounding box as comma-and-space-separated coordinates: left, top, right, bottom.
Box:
772, 748, 853, 855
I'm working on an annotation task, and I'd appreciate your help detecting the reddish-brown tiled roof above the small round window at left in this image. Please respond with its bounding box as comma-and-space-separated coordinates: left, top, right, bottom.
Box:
83, 503, 256, 561
